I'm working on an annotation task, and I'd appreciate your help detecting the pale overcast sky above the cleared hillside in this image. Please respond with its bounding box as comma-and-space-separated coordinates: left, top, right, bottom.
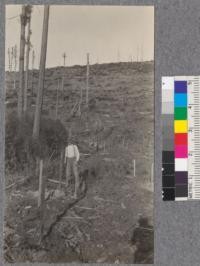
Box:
6, 5, 154, 69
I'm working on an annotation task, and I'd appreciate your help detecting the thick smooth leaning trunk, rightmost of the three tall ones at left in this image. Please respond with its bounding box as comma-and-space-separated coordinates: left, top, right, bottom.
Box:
33, 5, 49, 138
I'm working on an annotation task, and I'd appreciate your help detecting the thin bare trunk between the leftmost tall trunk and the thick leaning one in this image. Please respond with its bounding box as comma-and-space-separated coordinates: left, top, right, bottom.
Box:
24, 6, 32, 112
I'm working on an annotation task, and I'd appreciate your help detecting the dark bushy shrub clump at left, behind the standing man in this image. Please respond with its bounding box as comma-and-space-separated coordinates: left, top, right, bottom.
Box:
5, 114, 68, 171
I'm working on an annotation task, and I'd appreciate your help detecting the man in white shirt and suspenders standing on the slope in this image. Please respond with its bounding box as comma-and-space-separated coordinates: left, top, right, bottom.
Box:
65, 139, 80, 199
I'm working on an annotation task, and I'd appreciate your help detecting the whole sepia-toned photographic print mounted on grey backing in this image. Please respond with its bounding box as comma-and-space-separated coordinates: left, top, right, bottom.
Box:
4, 4, 154, 264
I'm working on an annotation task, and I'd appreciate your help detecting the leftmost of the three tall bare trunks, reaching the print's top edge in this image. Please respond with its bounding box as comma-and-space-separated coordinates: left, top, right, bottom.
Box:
17, 5, 26, 118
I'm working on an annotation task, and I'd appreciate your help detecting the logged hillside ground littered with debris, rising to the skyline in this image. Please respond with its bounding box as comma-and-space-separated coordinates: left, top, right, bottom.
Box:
4, 62, 154, 263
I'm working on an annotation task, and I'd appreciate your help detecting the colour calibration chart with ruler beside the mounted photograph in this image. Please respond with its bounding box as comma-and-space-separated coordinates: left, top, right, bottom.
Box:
162, 76, 200, 201
